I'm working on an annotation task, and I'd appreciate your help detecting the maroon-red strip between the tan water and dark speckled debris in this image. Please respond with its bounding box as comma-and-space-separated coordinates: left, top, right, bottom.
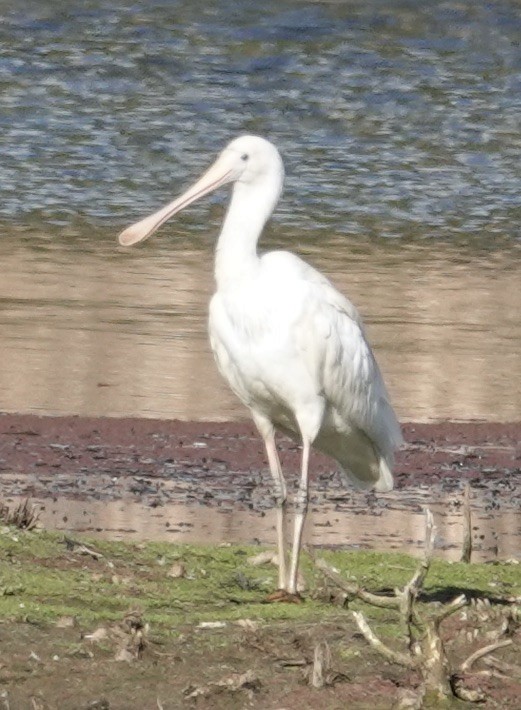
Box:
0, 414, 521, 495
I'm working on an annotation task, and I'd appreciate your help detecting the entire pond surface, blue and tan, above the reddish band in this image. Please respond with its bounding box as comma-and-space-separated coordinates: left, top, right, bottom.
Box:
0, 0, 521, 419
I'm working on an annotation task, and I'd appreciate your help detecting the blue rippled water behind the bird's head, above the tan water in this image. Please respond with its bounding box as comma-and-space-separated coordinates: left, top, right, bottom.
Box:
0, 0, 521, 239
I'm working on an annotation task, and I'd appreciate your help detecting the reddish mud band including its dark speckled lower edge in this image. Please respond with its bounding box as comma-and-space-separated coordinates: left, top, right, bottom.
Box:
0, 414, 521, 555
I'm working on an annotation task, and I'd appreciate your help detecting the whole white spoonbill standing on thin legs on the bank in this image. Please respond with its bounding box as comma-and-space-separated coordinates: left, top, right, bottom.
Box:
119, 136, 402, 599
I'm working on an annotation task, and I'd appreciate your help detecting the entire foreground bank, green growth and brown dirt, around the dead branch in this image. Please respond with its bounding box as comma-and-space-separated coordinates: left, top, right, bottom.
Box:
0, 527, 521, 710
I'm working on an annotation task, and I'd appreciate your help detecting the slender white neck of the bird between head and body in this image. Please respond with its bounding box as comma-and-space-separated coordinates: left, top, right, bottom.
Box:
215, 180, 281, 290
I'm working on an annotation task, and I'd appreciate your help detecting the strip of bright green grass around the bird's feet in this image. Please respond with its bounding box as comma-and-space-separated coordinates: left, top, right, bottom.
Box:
0, 528, 521, 633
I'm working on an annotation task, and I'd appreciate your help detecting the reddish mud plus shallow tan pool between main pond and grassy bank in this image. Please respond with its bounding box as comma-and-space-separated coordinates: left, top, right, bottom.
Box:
0, 414, 521, 559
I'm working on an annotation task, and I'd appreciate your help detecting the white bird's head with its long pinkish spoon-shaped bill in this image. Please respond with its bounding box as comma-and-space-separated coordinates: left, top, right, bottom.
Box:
119, 136, 284, 246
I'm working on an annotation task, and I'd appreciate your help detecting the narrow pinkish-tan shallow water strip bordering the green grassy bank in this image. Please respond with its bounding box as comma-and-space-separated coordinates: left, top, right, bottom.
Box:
9, 489, 521, 562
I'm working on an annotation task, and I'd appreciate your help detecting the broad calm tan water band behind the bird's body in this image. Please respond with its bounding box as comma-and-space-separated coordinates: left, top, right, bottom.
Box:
0, 237, 521, 420
